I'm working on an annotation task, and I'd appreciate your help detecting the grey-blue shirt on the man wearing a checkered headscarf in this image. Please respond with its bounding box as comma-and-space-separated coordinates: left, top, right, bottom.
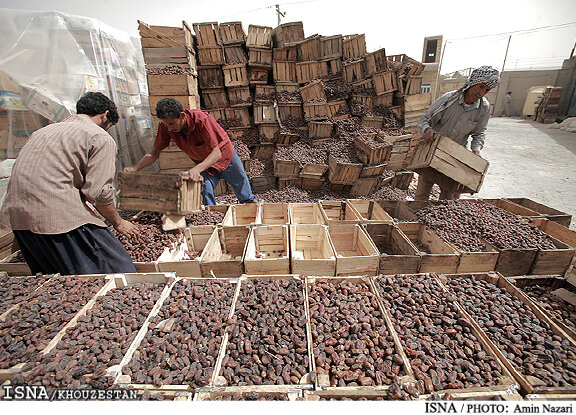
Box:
418, 91, 490, 151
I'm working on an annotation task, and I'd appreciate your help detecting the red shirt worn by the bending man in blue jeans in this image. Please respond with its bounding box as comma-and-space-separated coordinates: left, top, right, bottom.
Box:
154, 109, 234, 171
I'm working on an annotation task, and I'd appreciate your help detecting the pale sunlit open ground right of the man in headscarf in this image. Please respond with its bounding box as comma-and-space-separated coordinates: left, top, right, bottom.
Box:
466, 117, 576, 230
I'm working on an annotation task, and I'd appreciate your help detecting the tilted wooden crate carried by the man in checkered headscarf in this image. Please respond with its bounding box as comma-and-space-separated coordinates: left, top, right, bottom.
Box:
409, 134, 488, 193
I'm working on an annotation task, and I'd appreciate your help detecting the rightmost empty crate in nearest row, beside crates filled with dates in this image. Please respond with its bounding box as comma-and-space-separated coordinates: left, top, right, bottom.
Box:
398, 222, 460, 274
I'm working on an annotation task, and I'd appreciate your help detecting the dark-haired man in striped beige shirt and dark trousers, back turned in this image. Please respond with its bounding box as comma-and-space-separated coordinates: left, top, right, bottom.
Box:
2, 92, 139, 275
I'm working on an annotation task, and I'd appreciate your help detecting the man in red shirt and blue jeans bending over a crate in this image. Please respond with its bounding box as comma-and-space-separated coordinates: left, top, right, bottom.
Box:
124, 98, 254, 205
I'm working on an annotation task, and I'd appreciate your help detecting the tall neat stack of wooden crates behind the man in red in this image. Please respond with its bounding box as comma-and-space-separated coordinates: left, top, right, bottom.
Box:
138, 22, 200, 173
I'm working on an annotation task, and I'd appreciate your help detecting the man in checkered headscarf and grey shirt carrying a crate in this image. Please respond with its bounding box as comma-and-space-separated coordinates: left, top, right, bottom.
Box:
414, 66, 500, 200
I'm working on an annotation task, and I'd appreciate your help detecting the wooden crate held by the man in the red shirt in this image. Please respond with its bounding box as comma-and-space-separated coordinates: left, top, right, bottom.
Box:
118, 172, 202, 215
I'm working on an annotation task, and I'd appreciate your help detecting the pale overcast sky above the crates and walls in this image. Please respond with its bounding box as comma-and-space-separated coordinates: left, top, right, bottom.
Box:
0, 0, 576, 73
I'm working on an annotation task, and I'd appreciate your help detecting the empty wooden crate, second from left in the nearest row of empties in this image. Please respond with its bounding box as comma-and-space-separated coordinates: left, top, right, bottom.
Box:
200, 226, 250, 277
